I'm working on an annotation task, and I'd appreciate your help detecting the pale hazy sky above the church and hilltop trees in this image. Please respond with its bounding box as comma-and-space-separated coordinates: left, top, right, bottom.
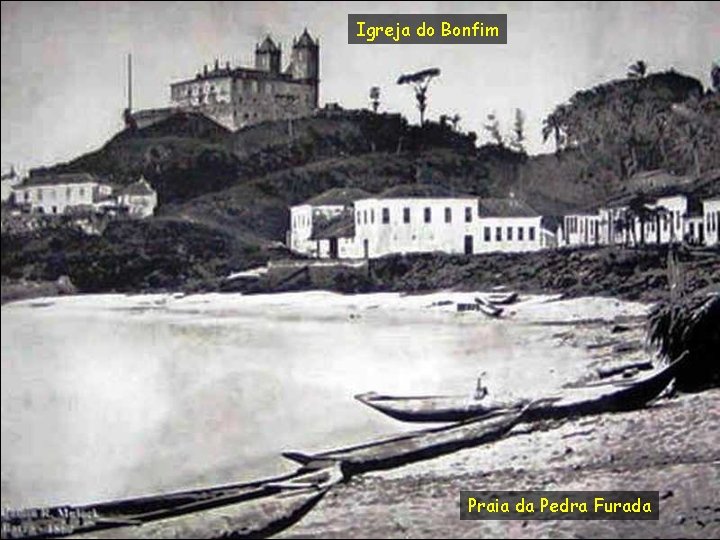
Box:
1, 1, 720, 171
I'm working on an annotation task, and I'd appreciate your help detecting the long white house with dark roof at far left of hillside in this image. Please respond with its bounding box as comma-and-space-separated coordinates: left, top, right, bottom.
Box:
13, 173, 112, 214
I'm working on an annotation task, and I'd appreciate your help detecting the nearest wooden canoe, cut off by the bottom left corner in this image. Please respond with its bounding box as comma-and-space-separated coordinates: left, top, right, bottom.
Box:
3, 466, 342, 538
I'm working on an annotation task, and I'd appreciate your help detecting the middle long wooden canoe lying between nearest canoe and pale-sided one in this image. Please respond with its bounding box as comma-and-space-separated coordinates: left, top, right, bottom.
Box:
283, 408, 528, 478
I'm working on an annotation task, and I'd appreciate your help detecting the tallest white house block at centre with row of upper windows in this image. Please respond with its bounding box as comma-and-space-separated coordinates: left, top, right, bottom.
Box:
353, 184, 478, 258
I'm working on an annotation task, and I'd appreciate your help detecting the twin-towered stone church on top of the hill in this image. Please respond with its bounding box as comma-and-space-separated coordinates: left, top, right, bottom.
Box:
166, 29, 320, 130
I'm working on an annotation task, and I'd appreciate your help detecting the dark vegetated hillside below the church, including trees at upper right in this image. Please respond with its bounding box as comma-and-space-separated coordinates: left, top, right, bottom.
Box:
2, 72, 720, 291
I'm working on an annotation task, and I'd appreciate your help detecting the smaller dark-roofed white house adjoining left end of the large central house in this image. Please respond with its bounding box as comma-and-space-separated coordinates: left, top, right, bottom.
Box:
286, 188, 369, 257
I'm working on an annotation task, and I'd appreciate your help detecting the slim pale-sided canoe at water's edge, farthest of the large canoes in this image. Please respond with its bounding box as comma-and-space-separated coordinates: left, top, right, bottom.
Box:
355, 392, 520, 422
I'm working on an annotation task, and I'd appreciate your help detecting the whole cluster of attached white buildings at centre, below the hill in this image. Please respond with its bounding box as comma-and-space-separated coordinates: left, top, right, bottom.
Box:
288, 188, 557, 259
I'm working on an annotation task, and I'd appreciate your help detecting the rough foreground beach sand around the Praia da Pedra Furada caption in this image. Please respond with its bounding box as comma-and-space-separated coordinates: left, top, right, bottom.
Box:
280, 390, 720, 538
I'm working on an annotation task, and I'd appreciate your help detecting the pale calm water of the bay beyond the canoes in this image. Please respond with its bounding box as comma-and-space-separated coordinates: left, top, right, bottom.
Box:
2, 293, 582, 507
